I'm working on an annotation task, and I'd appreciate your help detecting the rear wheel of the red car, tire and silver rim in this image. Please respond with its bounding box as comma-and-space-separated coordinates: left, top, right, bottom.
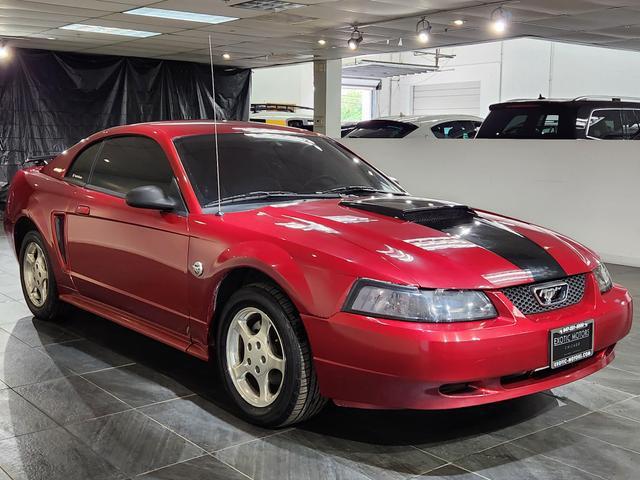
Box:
19, 230, 60, 321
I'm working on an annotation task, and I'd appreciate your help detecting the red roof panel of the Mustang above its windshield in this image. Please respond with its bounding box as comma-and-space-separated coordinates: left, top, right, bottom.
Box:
98, 120, 317, 138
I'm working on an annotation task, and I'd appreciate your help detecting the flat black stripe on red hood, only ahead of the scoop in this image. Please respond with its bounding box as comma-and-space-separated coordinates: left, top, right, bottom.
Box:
437, 217, 567, 282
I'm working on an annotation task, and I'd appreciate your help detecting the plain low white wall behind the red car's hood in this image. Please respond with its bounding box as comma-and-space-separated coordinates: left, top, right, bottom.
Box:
342, 138, 640, 267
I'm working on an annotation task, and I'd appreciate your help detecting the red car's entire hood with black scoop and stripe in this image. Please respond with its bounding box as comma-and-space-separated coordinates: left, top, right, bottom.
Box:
220, 196, 598, 289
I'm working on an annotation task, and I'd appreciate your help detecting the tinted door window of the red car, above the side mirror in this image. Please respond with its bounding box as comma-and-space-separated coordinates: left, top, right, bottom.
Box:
91, 136, 177, 196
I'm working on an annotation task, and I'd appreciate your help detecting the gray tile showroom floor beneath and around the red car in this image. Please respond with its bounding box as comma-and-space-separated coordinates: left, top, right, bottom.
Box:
0, 231, 640, 480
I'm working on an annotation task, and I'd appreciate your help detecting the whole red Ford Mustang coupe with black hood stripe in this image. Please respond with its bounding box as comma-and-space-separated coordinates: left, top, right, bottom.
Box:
5, 121, 632, 426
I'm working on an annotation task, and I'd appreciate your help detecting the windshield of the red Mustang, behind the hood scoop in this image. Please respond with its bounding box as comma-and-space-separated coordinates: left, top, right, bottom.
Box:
174, 129, 403, 206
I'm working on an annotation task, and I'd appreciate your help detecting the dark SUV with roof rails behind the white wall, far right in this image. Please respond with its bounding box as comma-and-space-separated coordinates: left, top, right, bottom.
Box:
476, 97, 640, 140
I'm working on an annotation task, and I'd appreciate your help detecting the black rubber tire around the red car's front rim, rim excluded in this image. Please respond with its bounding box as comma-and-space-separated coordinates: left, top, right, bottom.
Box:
216, 285, 303, 427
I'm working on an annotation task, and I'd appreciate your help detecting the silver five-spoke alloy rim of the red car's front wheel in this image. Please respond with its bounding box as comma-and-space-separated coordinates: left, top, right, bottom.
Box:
225, 307, 286, 408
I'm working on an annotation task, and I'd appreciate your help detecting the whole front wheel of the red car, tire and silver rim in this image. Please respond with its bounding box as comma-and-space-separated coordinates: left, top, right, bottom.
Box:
216, 283, 326, 428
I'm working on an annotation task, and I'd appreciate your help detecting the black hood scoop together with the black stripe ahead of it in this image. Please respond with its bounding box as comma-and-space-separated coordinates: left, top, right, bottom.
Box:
340, 197, 567, 282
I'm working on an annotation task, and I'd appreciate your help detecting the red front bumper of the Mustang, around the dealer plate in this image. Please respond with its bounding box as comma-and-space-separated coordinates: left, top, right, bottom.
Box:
303, 275, 633, 409
